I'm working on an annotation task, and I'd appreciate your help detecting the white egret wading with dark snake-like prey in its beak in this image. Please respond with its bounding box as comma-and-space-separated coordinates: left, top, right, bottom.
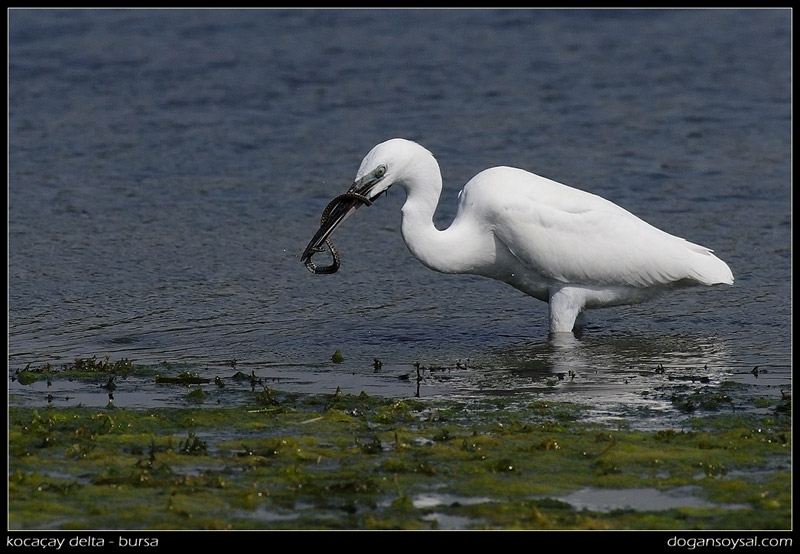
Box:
301, 139, 733, 333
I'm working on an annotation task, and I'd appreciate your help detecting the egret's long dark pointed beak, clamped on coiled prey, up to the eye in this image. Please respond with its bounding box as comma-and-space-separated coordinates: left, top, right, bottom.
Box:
300, 165, 389, 271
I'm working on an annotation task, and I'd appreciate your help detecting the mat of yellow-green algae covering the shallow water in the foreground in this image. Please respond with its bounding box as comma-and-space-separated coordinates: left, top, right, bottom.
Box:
9, 383, 791, 529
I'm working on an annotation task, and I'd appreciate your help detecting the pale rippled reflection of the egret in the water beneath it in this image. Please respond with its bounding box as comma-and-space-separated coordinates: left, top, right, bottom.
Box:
423, 334, 744, 428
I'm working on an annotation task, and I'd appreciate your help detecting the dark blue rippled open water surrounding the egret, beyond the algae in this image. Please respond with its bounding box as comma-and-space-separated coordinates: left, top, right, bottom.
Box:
8, 9, 792, 411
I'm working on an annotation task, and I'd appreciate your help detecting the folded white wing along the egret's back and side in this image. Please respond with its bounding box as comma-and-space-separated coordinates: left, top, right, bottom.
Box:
464, 168, 716, 287
